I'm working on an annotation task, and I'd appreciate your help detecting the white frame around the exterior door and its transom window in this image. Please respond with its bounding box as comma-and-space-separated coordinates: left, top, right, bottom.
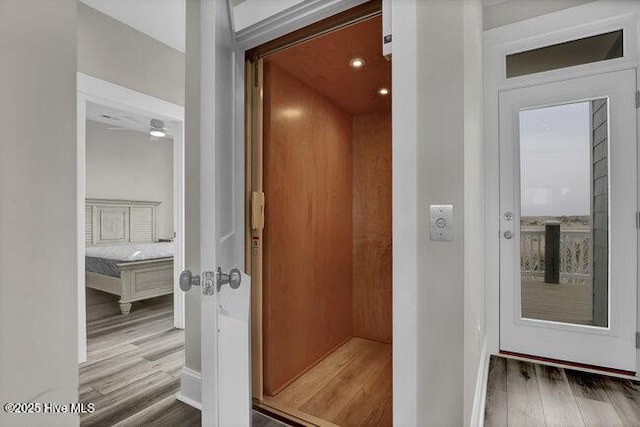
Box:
483, 0, 640, 378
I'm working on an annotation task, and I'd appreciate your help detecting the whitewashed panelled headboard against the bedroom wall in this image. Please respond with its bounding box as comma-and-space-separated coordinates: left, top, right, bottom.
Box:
84, 199, 160, 246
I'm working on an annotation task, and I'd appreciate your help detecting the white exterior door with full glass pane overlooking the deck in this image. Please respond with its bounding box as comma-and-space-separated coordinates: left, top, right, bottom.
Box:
500, 69, 638, 372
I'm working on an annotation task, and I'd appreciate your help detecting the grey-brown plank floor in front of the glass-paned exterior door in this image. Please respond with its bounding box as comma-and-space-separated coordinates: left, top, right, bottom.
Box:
485, 356, 640, 427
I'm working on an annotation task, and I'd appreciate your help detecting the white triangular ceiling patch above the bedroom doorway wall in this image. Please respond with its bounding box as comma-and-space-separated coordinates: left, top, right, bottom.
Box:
80, 0, 186, 52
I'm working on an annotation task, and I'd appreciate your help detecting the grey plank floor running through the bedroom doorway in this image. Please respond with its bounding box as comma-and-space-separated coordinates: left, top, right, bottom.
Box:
79, 289, 200, 426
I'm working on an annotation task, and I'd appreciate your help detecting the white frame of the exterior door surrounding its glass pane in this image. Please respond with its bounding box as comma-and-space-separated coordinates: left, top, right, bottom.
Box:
500, 68, 638, 375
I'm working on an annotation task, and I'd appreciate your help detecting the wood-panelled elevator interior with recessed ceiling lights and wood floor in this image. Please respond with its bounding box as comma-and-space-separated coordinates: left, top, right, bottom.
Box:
248, 15, 392, 426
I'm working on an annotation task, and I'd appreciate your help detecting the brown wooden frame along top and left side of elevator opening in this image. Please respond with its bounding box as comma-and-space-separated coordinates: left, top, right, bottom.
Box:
244, 1, 391, 422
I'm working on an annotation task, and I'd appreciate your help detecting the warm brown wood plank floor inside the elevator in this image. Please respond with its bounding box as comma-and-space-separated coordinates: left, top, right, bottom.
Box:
265, 338, 392, 427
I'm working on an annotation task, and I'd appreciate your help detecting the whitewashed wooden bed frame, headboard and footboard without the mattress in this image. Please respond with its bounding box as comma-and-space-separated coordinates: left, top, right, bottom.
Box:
85, 199, 173, 314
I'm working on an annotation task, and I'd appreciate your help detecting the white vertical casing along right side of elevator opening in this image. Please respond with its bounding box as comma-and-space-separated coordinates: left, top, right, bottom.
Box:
391, 0, 423, 426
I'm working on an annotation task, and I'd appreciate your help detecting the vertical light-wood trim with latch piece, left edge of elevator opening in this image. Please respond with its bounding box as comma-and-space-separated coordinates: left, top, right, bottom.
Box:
245, 58, 264, 401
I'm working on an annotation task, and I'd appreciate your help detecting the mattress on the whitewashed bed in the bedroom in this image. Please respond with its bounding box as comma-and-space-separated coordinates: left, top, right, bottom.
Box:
84, 242, 174, 277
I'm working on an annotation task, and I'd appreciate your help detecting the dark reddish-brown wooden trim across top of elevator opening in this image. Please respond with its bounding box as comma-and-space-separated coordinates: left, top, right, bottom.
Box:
245, 0, 382, 60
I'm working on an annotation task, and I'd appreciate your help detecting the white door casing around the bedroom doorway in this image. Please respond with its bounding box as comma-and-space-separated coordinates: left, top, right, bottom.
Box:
76, 72, 185, 363
